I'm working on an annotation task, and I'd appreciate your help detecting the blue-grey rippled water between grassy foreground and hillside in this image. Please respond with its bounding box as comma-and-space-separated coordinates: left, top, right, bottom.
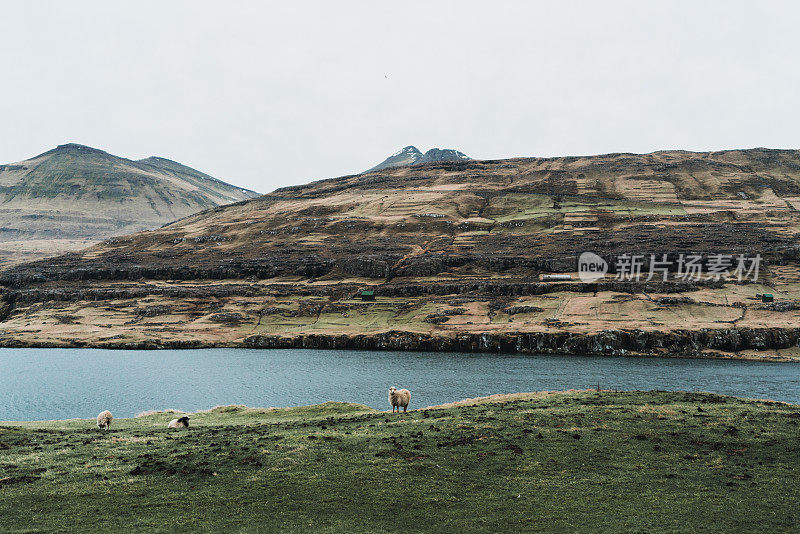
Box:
0, 349, 800, 421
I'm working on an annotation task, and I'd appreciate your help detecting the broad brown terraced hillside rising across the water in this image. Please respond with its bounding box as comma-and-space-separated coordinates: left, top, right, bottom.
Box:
2, 149, 800, 358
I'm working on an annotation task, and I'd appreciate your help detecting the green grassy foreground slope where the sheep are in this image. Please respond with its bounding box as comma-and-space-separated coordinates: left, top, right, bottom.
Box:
0, 392, 800, 532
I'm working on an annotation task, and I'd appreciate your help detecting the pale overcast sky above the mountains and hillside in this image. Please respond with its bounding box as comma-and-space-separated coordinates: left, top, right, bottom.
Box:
0, 0, 800, 192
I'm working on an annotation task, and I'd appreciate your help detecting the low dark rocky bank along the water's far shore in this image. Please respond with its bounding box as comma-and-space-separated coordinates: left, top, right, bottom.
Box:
0, 328, 800, 363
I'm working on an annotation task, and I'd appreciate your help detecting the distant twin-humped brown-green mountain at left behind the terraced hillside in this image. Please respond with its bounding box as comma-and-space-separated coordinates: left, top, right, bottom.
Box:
0, 143, 258, 265
